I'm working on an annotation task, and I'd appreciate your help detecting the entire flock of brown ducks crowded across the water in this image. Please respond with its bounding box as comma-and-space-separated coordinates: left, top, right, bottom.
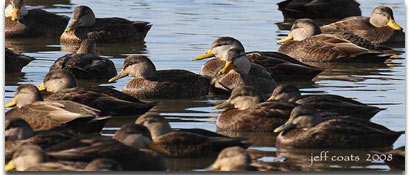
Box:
5, 0, 405, 171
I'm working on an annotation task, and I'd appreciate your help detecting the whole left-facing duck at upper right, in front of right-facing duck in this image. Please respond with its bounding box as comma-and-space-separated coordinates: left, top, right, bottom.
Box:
278, 18, 391, 63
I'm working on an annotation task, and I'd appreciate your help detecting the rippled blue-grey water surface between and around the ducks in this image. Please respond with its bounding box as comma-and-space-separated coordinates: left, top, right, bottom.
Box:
5, 0, 405, 170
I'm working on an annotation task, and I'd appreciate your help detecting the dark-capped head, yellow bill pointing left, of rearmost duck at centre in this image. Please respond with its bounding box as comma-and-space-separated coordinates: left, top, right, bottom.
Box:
194, 37, 245, 60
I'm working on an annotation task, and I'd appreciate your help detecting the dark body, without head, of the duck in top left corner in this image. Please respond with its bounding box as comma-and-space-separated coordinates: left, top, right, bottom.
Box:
5, 9, 69, 38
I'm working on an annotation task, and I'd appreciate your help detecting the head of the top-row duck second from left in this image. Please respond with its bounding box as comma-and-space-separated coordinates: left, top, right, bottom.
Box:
65, 5, 95, 32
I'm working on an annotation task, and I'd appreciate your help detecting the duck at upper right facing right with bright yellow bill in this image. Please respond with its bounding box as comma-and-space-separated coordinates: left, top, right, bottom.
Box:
321, 6, 405, 44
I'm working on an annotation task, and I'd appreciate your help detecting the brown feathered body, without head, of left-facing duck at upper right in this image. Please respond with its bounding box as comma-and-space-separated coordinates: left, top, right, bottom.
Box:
278, 34, 391, 62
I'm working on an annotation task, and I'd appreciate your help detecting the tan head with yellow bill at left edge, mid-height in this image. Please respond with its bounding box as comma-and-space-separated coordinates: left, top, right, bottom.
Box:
5, 84, 43, 108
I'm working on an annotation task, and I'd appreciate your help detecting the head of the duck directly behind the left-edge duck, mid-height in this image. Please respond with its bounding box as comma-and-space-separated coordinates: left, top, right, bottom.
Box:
38, 69, 77, 93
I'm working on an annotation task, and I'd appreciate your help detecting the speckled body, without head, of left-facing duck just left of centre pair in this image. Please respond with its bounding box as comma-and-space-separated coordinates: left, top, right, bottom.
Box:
122, 70, 209, 99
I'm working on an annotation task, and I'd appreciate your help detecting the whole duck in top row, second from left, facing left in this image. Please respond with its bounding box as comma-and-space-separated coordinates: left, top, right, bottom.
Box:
60, 6, 152, 44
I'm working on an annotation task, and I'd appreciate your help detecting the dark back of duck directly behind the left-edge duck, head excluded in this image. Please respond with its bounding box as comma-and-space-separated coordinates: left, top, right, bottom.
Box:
46, 88, 153, 115
